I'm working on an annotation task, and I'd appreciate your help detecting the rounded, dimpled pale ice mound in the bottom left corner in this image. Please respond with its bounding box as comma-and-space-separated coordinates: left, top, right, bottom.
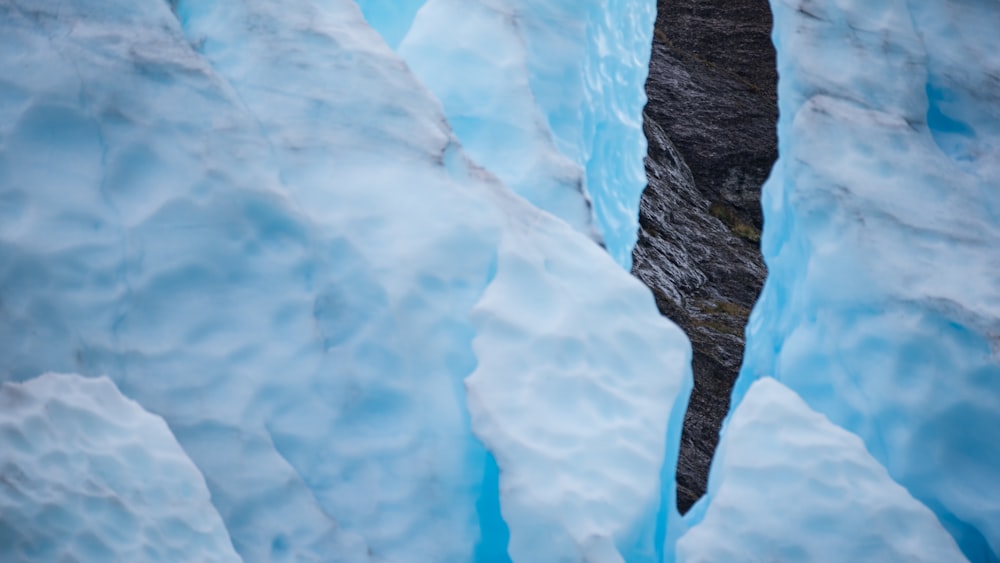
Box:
0, 373, 240, 563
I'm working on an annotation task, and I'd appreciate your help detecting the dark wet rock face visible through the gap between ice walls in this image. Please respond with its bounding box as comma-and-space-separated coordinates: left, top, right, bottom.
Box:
633, 0, 777, 512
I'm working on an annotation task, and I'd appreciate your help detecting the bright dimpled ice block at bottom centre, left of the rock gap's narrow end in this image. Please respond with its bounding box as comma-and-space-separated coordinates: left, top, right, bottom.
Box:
466, 207, 691, 561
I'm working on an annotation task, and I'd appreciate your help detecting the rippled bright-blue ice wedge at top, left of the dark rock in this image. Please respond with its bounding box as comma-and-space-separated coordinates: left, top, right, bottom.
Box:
399, 0, 656, 269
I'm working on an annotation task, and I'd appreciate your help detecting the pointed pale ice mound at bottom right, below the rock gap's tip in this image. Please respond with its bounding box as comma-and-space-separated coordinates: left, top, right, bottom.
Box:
677, 377, 966, 563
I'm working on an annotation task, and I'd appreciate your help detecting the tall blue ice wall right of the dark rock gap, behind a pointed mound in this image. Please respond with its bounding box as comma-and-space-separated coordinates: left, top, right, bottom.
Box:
734, 0, 1000, 561
